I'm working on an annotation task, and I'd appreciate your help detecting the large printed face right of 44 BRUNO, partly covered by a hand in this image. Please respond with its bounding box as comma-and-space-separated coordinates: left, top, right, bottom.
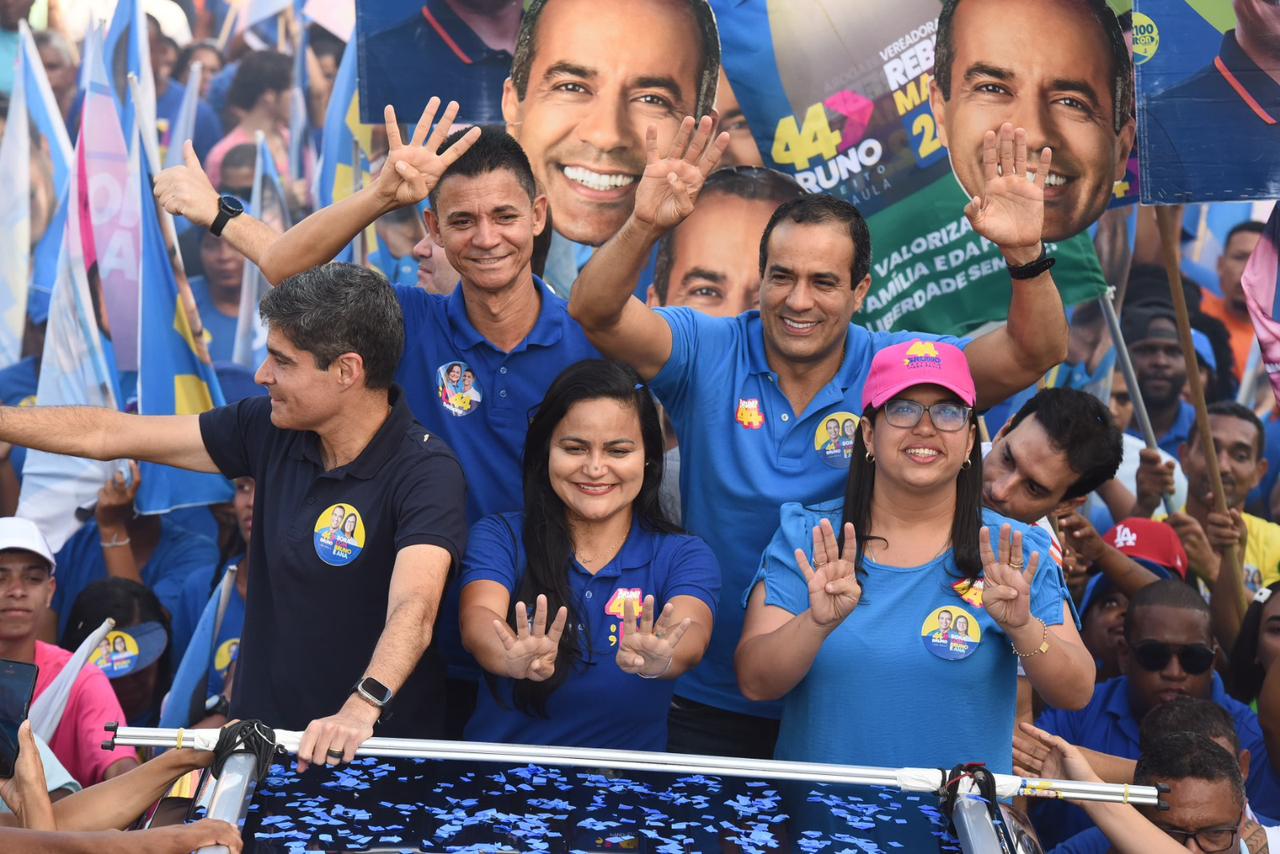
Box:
929, 0, 1134, 242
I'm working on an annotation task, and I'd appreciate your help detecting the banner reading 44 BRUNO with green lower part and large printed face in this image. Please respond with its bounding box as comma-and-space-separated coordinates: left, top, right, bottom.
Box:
713, 0, 1133, 332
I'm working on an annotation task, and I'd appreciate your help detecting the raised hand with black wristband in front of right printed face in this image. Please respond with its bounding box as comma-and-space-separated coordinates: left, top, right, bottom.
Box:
964, 122, 1053, 257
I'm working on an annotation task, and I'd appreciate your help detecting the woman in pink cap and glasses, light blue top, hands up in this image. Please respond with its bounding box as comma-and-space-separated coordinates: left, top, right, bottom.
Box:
736, 341, 1093, 773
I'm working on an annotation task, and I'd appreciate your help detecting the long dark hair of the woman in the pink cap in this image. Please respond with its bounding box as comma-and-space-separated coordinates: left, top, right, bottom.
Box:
840, 406, 982, 581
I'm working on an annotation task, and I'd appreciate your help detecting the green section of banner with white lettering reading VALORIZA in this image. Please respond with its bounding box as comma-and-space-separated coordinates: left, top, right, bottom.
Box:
855, 174, 1106, 334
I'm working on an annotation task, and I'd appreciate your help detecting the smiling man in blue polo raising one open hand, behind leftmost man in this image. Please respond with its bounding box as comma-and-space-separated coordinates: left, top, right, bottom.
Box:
156, 99, 599, 735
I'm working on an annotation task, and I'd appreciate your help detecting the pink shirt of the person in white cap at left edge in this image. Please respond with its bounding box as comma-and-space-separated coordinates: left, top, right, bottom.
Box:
36, 640, 138, 787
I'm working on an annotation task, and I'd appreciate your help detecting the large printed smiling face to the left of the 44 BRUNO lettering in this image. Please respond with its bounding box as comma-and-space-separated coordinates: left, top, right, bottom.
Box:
502, 0, 721, 246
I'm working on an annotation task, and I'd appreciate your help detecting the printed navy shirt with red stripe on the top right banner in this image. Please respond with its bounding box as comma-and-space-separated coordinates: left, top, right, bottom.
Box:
1138, 29, 1280, 204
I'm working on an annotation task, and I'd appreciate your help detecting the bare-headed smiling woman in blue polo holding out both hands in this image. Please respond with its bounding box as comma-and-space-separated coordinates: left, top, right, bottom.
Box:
462, 360, 719, 750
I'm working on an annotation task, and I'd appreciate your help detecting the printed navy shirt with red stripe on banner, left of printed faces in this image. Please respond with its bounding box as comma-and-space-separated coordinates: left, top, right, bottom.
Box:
358, 0, 512, 124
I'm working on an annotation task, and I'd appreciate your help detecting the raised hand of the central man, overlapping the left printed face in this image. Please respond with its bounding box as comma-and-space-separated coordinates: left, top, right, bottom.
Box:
634, 115, 728, 230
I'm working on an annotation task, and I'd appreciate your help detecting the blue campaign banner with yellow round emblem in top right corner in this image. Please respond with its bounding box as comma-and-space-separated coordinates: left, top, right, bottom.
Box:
1134, 0, 1280, 204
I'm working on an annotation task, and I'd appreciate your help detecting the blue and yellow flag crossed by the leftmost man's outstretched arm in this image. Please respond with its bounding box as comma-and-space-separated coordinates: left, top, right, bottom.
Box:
134, 153, 234, 513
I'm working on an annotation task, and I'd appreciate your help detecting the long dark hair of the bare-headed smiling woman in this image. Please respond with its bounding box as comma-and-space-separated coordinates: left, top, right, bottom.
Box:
504, 359, 680, 717
